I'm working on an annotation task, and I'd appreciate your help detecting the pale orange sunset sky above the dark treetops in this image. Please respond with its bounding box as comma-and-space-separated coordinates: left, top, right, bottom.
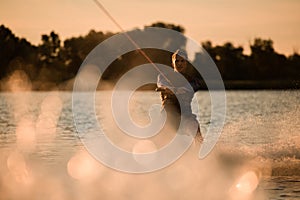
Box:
0, 0, 300, 55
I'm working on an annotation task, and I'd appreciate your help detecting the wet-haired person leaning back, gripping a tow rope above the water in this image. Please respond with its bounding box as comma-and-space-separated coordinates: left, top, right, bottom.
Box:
156, 50, 202, 141
